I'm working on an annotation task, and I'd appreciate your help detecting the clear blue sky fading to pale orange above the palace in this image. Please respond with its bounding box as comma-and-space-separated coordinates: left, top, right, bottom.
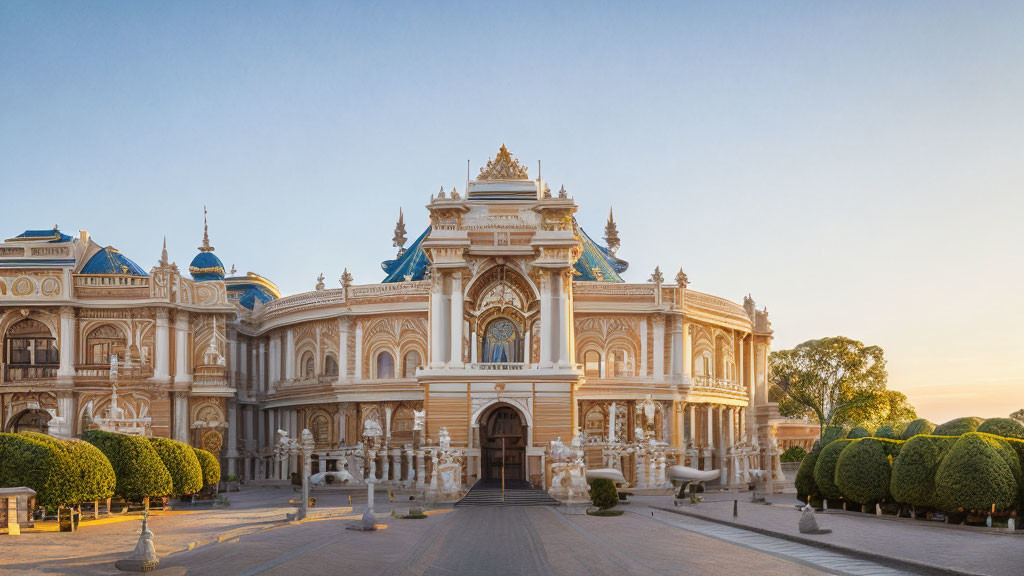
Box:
0, 0, 1024, 420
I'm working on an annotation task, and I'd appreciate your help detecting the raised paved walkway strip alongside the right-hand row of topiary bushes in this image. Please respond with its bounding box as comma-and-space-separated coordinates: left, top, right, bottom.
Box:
631, 495, 1024, 576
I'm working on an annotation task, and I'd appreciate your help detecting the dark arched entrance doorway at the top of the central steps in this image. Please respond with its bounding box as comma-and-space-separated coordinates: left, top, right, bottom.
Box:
480, 406, 526, 484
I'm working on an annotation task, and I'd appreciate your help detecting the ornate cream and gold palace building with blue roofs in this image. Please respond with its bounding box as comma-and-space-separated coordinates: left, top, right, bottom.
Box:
0, 147, 772, 485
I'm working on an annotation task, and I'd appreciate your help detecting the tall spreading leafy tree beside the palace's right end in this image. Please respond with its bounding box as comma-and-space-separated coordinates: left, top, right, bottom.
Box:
770, 336, 888, 444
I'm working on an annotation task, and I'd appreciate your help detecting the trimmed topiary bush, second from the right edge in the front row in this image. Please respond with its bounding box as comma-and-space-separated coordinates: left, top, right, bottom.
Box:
889, 435, 956, 507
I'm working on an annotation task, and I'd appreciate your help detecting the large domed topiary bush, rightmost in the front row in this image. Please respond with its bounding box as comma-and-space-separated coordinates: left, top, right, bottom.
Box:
935, 426, 1021, 511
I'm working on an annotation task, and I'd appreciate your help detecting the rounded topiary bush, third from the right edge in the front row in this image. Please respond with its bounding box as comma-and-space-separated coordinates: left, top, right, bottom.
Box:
836, 438, 902, 504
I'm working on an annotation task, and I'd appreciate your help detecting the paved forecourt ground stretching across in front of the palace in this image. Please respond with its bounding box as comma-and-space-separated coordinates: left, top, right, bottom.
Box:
0, 488, 1024, 576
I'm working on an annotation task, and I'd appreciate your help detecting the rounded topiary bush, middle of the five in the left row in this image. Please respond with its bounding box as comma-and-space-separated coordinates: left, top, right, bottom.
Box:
82, 430, 173, 501
